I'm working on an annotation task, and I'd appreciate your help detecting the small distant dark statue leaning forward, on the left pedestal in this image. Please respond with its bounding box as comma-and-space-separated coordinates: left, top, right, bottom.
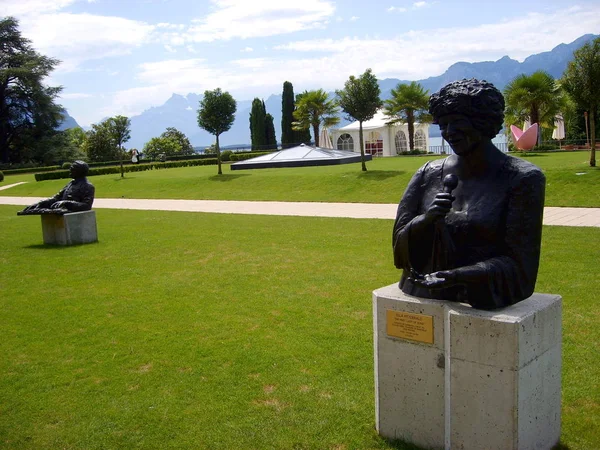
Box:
17, 161, 95, 216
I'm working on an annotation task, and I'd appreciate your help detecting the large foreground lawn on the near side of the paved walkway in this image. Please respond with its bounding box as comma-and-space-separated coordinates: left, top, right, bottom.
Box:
0, 206, 600, 450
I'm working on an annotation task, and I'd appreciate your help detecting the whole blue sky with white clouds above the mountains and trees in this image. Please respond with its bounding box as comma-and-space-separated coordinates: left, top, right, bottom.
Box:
0, 0, 600, 126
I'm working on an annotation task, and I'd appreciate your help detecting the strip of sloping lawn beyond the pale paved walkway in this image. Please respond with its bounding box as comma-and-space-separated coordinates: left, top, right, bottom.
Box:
0, 152, 600, 207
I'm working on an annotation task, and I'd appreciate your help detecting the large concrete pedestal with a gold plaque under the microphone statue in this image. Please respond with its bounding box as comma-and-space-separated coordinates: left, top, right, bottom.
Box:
373, 284, 562, 450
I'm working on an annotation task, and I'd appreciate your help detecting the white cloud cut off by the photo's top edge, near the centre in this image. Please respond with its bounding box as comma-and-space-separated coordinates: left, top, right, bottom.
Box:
162, 0, 335, 45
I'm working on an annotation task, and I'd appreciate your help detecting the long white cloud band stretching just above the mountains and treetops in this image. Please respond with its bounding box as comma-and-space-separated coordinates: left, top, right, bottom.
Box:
64, 5, 600, 123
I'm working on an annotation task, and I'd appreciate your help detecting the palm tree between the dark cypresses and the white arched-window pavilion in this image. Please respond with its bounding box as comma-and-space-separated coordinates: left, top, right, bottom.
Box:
292, 89, 340, 147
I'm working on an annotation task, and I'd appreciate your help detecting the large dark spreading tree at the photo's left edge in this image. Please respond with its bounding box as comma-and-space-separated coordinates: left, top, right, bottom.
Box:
0, 17, 64, 163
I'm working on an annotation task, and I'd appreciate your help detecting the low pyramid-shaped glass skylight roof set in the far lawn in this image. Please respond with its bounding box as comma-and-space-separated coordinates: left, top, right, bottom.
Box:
231, 144, 371, 170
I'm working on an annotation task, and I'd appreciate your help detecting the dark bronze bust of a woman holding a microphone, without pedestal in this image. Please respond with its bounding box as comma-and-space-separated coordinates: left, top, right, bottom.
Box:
393, 79, 545, 309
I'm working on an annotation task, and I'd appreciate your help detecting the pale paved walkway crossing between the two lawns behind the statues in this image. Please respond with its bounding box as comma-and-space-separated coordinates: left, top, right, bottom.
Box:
0, 196, 600, 227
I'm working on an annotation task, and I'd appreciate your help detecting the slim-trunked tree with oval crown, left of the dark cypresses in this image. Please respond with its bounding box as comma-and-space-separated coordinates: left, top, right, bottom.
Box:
198, 88, 237, 175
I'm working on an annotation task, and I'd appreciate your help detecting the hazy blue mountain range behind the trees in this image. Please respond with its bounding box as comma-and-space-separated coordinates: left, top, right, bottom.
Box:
63, 34, 598, 149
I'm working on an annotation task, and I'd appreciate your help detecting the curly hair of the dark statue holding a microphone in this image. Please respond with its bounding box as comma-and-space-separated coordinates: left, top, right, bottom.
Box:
429, 78, 504, 139
